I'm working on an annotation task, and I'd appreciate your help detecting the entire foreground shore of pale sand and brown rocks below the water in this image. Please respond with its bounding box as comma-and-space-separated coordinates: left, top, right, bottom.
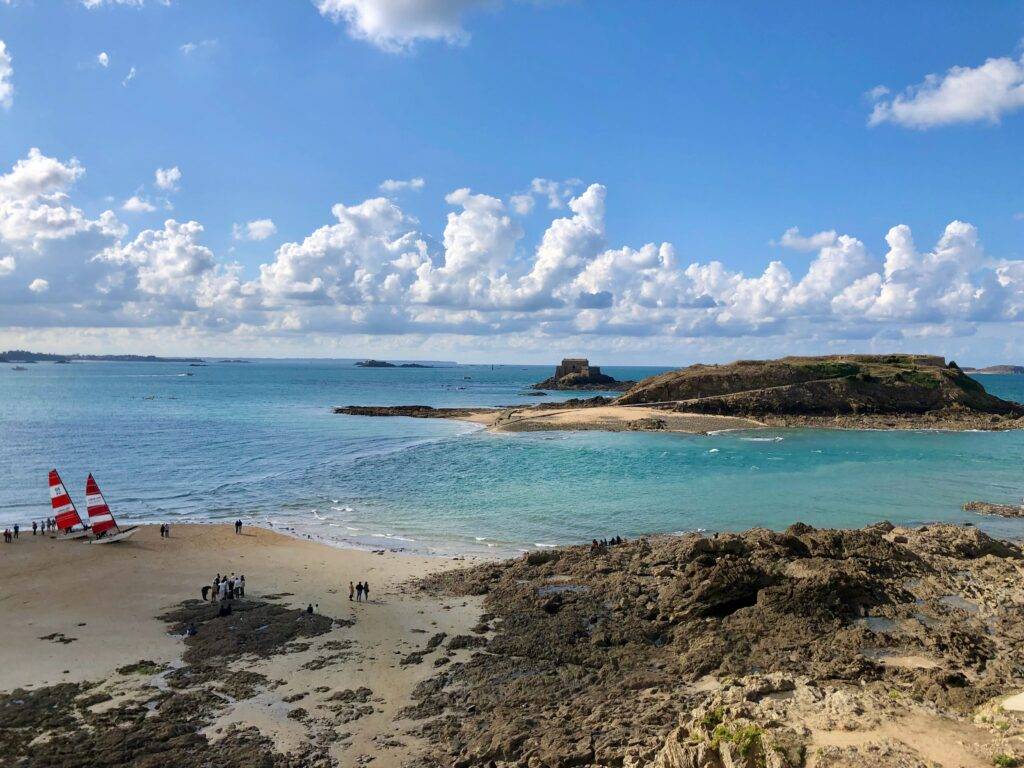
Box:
8, 523, 1024, 768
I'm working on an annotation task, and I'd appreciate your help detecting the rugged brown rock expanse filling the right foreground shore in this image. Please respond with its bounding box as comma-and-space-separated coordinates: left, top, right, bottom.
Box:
406, 523, 1024, 768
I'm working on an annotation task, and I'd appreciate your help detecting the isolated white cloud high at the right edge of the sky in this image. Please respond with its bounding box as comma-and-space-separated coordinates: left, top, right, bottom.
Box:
867, 56, 1024, 129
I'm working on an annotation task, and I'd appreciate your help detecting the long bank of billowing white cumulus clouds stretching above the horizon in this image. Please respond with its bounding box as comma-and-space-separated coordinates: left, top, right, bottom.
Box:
0, 148, 1024, 358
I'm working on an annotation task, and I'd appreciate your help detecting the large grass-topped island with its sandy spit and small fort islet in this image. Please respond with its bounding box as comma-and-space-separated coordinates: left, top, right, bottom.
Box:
335, 354, 1024, 432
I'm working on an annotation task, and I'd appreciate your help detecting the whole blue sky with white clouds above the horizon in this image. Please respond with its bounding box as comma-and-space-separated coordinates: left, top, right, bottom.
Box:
0, 0, 1024, 365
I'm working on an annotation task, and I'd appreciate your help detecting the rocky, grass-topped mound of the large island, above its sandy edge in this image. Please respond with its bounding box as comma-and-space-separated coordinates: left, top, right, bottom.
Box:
616, 354, 1024, 428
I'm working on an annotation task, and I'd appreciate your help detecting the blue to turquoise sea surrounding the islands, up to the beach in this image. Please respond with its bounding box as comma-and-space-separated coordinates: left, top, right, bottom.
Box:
0, 360, 1024, 554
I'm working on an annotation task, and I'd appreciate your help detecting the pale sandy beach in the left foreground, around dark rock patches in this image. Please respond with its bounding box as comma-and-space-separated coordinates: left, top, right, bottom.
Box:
0, 525, 479, 766
